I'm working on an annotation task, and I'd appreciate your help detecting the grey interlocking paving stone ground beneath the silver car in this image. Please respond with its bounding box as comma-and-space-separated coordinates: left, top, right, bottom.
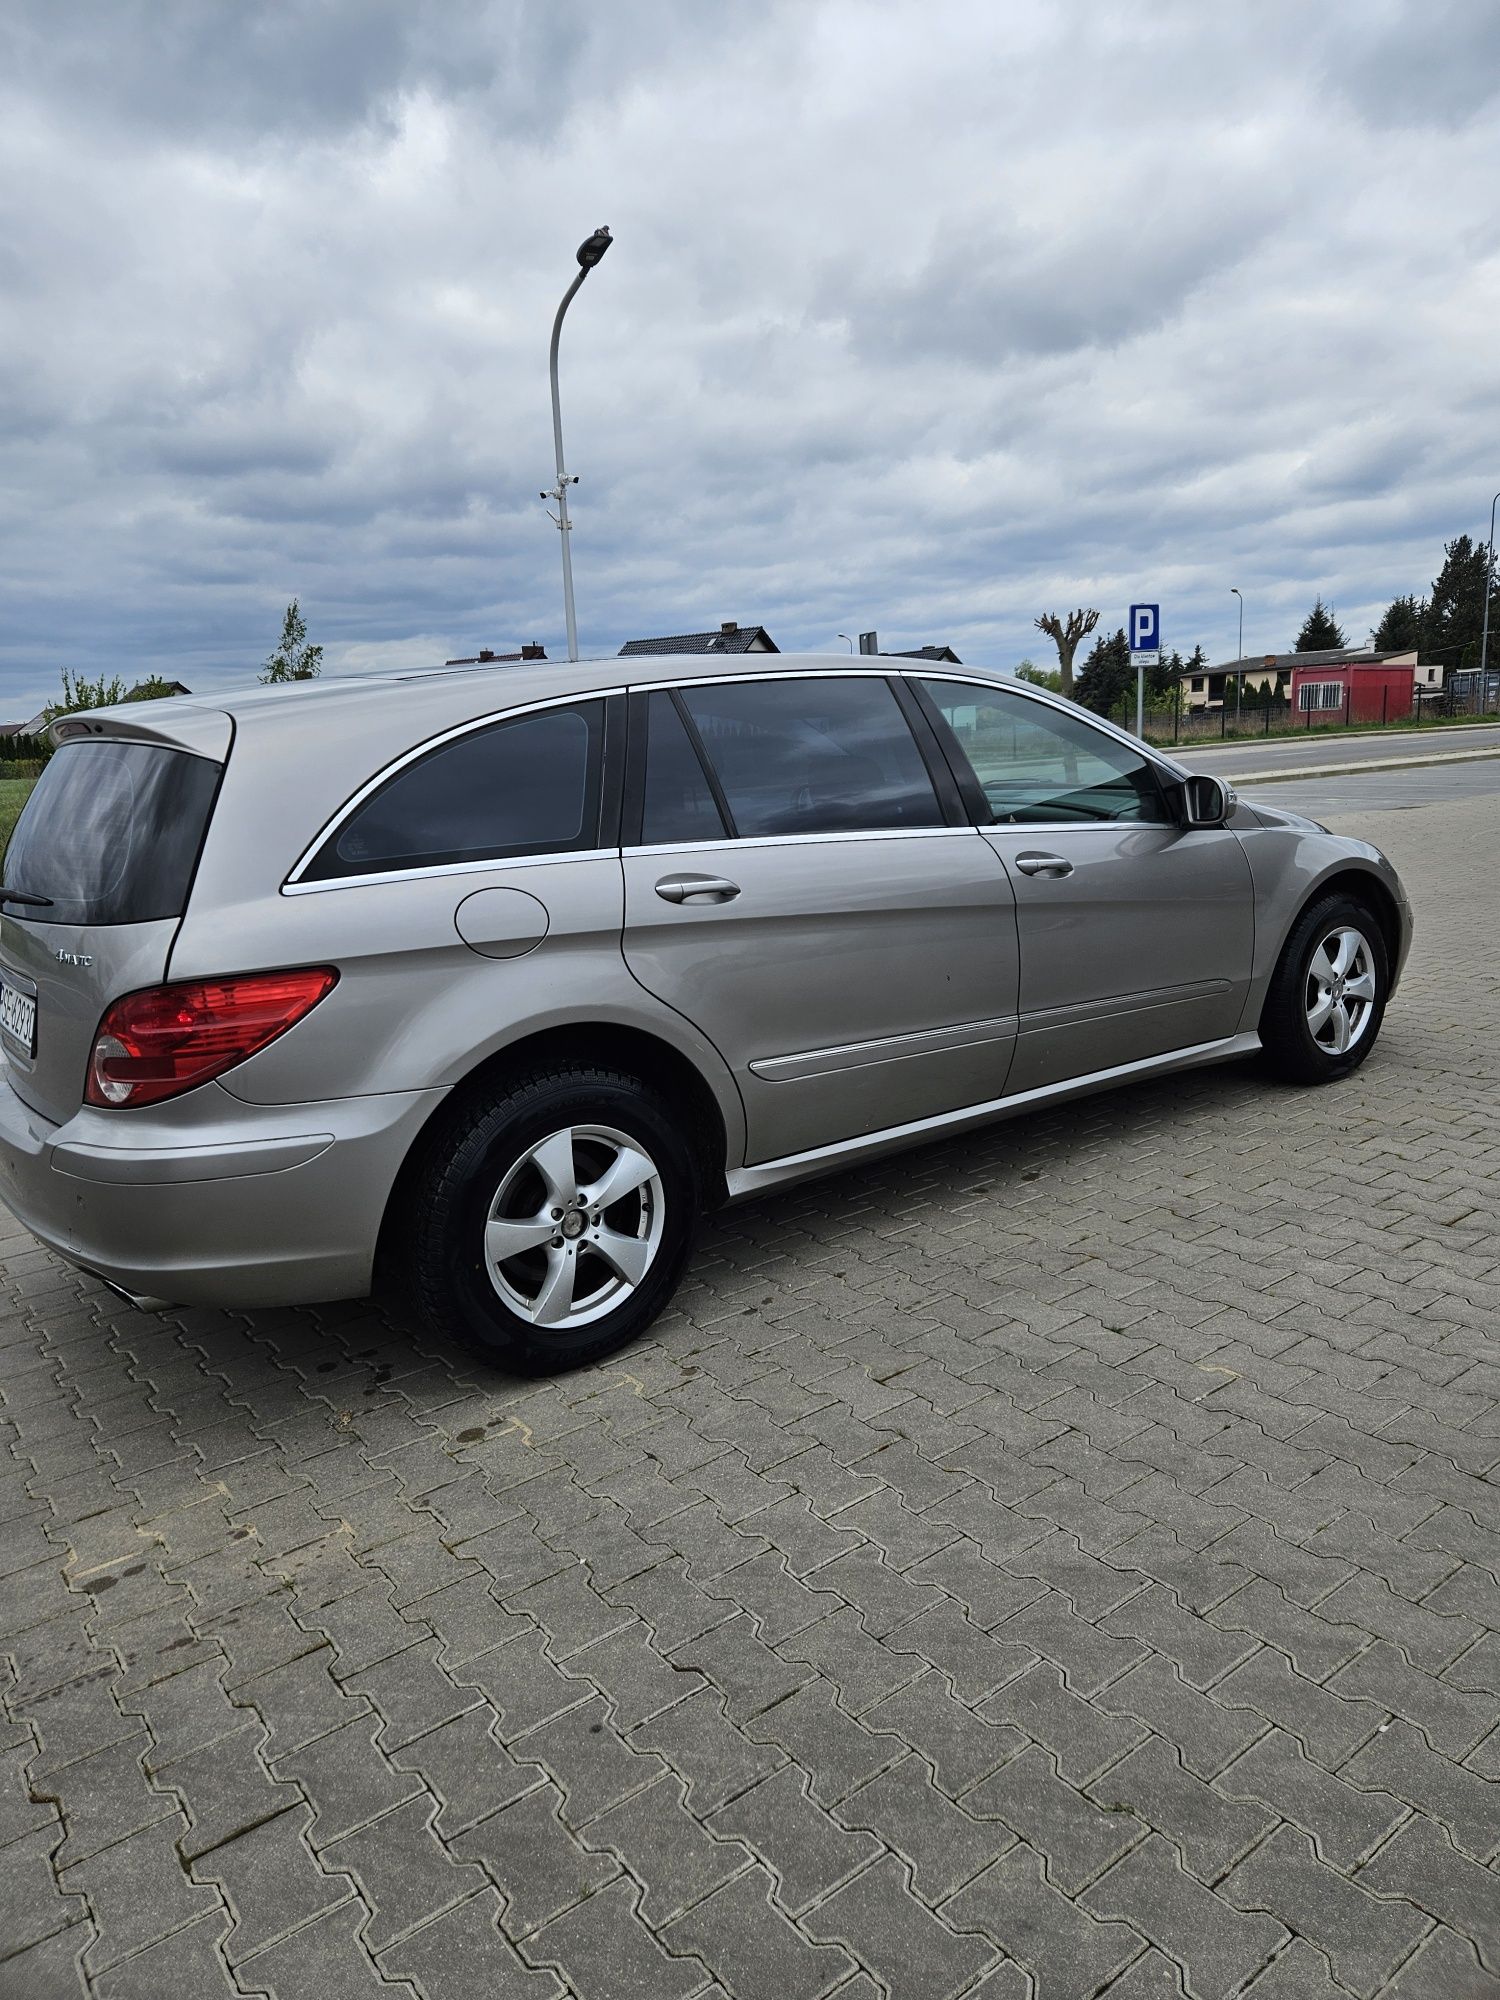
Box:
0, 800, 1500, 2000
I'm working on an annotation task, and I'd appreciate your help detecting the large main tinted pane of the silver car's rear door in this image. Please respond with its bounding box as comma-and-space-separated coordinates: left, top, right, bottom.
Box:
680, 676, 944, 840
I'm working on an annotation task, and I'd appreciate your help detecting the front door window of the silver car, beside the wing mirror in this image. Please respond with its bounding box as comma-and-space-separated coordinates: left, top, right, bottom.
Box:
922, 680, 1172, 826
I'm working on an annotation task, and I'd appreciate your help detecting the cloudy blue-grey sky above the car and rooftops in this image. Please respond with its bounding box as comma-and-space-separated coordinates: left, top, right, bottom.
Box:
0, 0, 1500, 718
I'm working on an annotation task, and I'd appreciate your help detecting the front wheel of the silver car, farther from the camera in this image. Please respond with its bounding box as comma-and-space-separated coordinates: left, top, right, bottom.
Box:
1260, 892, 1390, 1084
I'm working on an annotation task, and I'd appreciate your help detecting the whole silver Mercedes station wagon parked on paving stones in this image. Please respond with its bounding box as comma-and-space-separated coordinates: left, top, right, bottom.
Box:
0, 654, 1410, 1370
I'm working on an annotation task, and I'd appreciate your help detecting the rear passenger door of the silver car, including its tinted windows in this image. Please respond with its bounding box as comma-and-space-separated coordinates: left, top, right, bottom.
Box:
624, 674, 1018, 1164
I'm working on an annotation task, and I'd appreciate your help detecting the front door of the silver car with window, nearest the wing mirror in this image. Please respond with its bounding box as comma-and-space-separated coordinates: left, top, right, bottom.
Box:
922, 680, 1254, 1094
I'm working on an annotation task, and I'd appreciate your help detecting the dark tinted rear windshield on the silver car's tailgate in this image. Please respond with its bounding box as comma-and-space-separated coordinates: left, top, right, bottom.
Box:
2, 740, 222, 924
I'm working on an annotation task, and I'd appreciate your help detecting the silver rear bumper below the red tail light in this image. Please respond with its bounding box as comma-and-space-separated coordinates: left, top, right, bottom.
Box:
0, 1074, 446, 1306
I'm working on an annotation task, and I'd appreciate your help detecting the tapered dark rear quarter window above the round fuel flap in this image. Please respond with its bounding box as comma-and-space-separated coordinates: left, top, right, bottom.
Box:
302, 702, 604, 882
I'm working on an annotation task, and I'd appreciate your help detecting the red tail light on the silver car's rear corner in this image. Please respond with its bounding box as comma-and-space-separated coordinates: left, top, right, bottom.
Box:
84, 966, 338, 1110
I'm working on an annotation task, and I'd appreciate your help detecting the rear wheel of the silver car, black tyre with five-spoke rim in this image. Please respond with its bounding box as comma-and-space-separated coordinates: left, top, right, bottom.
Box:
406, 1064, 702, 1374
